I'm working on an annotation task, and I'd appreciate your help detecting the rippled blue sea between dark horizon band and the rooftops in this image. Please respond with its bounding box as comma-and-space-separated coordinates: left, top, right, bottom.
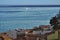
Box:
0, 7, 60, 32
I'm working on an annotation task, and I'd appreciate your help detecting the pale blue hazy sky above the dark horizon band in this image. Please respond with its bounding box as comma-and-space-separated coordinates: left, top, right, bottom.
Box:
0, 0, 60, 5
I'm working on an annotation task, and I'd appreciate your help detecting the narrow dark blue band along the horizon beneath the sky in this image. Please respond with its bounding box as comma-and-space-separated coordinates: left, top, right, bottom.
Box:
0, 5, 60, 7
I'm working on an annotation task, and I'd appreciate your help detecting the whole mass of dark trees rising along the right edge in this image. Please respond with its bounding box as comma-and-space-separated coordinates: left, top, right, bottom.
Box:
50, 11, 60, 40
